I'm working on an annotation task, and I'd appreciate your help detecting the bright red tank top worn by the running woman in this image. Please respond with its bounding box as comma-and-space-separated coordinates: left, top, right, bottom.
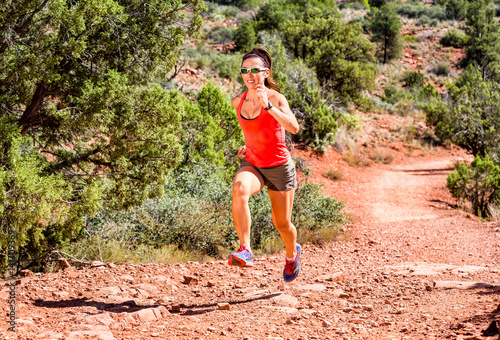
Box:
236, 91, 290, 168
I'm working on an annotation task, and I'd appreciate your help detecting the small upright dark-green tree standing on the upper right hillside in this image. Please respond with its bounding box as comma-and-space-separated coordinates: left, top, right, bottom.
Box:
370, 5, 403, 64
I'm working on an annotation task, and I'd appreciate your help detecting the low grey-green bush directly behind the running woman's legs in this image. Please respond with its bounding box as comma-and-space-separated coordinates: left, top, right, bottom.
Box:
86, 164, 347, 257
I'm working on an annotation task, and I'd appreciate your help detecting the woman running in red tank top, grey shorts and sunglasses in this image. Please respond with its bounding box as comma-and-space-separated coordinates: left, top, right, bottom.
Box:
228, 47, 302, 282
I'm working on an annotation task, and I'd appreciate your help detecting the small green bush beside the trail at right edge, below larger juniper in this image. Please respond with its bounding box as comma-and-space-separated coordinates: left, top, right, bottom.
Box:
447, 156, 500, 217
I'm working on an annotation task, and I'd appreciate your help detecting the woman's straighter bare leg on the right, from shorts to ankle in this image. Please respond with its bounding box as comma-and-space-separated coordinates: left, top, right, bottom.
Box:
267, 188, 297, 258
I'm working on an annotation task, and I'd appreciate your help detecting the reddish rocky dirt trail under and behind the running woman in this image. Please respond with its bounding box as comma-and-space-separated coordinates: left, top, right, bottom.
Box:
0, 157, 500, 340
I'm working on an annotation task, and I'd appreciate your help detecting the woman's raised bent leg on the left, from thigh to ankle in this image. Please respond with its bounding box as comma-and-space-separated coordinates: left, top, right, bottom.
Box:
232, 166, 264, 249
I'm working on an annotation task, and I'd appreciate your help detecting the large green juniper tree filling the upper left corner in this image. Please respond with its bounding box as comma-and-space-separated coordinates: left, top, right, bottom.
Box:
0, 0, 204, 268
